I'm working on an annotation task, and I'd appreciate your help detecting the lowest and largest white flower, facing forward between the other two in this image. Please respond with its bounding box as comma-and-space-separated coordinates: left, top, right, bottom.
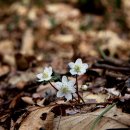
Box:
55, 76, 76, 101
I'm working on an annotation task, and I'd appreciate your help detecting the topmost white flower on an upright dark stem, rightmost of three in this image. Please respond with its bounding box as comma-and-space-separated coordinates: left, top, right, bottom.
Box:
68, 58, 88, 75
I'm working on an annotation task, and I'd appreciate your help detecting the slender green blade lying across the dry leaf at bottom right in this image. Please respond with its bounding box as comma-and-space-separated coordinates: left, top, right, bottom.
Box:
90, 102, 117, 130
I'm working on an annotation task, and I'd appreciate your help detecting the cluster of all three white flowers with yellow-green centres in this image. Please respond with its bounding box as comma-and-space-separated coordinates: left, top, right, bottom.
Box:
36, 59, 88, 101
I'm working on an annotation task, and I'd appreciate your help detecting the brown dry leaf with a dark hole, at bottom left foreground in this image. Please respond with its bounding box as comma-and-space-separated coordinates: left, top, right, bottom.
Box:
19, 106, 54, 130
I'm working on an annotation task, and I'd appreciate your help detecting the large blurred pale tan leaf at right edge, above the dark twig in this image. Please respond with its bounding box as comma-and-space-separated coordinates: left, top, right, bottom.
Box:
88, 30, 130, 59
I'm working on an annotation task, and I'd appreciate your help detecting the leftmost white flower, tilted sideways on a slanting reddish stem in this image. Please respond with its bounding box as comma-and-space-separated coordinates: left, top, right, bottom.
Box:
36, 67, 52, 82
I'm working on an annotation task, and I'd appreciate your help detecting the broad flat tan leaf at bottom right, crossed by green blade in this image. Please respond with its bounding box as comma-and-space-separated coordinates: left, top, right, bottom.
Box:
54, 107, 130, 130
